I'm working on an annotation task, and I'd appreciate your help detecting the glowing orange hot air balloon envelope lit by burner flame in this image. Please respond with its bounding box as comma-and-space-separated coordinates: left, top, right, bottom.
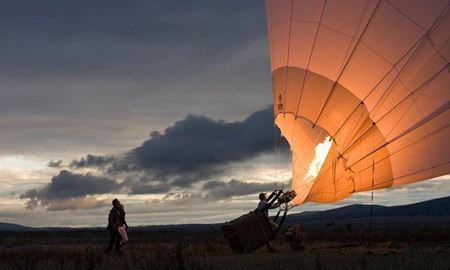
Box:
266, 0, 450, 205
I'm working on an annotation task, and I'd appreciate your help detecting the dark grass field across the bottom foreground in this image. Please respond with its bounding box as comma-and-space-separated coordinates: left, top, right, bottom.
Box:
0, 220, 450, 270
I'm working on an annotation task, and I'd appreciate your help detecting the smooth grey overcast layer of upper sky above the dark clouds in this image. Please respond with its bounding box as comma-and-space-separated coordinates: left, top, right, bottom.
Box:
0, 0, 271, 158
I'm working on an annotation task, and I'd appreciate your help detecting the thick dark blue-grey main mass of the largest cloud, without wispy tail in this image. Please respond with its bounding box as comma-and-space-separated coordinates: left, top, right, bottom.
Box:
125, 108, 275, 187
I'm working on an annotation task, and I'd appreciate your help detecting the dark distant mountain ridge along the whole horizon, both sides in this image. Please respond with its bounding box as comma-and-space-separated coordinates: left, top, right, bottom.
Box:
0, 196, 450, 231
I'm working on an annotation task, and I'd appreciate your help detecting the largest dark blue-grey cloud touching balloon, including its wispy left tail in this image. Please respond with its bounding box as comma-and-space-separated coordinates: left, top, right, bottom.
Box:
60, 108, 279, 190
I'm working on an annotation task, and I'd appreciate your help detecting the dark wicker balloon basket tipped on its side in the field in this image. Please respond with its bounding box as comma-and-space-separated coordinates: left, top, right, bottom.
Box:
221, 211, 275, 253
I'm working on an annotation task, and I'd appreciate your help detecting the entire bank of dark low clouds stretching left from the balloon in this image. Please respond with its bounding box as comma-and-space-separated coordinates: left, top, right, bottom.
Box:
20, 108, 286, 211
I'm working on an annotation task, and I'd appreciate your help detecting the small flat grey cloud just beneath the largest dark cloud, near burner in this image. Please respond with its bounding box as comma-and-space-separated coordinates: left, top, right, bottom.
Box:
203, 179, 274, 199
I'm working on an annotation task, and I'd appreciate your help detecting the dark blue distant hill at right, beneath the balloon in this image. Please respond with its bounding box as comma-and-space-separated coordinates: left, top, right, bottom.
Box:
287, 196, 450, 221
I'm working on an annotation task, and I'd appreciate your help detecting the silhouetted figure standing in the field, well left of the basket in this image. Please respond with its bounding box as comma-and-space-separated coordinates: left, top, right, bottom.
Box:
107, 199, 128, 254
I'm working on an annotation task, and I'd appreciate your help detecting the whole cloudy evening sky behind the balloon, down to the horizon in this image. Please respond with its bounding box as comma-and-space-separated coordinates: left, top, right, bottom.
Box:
0, 0, 450, 226
